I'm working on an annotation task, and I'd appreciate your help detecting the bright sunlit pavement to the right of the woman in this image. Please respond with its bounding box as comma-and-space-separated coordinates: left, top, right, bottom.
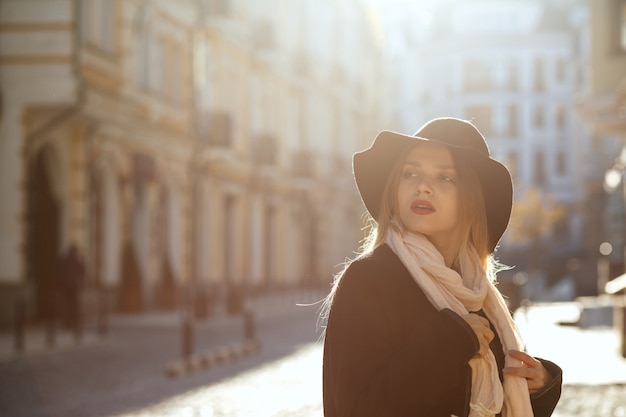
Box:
516, 303, 626, 417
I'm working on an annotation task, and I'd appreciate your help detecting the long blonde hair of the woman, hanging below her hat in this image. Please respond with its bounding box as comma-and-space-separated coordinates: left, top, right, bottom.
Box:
320, 144, 506, 319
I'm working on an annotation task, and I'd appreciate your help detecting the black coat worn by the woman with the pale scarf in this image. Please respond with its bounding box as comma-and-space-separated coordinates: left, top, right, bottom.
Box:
323, 245, 561, 417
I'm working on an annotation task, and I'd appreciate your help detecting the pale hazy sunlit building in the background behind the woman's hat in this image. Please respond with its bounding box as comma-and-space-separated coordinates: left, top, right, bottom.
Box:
372, 0, 595, 292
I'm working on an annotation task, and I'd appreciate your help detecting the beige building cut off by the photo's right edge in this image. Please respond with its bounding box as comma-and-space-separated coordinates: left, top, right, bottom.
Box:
579, 0, 626, 284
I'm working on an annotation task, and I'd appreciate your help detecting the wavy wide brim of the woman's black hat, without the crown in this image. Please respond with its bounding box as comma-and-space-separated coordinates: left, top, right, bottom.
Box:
352, 130, 513, 252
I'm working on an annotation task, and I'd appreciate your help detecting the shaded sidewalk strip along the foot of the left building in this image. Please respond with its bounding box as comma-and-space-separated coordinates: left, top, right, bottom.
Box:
0, 290, 325, 362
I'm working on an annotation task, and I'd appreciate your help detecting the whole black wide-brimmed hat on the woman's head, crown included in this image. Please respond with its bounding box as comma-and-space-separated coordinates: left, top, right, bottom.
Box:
352, 117, 513, 252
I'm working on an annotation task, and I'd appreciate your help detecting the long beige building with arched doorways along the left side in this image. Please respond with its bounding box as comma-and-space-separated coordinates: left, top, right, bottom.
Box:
0, 0, 383, 322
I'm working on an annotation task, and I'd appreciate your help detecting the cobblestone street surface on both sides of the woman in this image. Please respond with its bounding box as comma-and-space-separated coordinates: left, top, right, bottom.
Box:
0, 294, 626, 417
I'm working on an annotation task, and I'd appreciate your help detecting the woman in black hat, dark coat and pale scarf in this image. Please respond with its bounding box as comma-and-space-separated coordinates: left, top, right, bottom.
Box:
323, 118, 561, 417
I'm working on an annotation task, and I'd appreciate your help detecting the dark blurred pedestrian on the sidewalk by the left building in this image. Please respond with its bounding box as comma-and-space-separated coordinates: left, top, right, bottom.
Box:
58, 244, 85, 330
